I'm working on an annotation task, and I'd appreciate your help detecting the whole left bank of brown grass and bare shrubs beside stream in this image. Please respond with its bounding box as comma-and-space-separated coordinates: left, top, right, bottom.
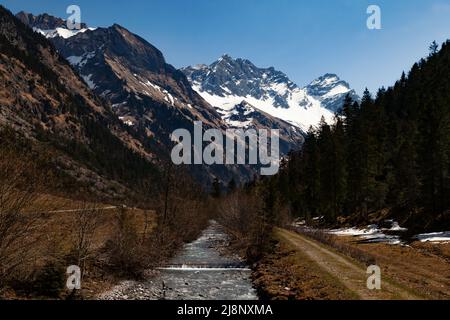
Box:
0, 134, 210, 299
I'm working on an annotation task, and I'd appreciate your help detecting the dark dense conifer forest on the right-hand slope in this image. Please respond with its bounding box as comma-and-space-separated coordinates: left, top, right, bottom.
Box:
270, 41, 450, 230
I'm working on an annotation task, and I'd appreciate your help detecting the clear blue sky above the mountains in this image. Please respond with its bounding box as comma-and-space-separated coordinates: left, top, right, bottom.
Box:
0, 0, 450, 93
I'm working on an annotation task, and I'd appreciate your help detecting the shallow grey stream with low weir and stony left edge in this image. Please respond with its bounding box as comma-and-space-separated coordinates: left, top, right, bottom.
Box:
102, 221, 258, 300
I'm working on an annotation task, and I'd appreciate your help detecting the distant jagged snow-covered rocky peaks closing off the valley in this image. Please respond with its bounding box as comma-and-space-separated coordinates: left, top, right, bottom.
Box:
182, 54, 357, 131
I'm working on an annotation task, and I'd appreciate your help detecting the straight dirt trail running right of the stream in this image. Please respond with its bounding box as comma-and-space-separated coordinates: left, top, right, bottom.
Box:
277, 229, 421, 300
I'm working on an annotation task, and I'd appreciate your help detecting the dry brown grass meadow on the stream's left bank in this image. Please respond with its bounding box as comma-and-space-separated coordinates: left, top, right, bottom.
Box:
0, 196, 156, 298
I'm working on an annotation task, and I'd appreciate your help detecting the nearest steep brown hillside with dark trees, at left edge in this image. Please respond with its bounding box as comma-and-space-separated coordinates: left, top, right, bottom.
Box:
0, 7, 162, 199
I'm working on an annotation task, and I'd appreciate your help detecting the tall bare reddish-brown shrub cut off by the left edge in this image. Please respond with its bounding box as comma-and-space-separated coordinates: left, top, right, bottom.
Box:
0, 148, 49, 287
